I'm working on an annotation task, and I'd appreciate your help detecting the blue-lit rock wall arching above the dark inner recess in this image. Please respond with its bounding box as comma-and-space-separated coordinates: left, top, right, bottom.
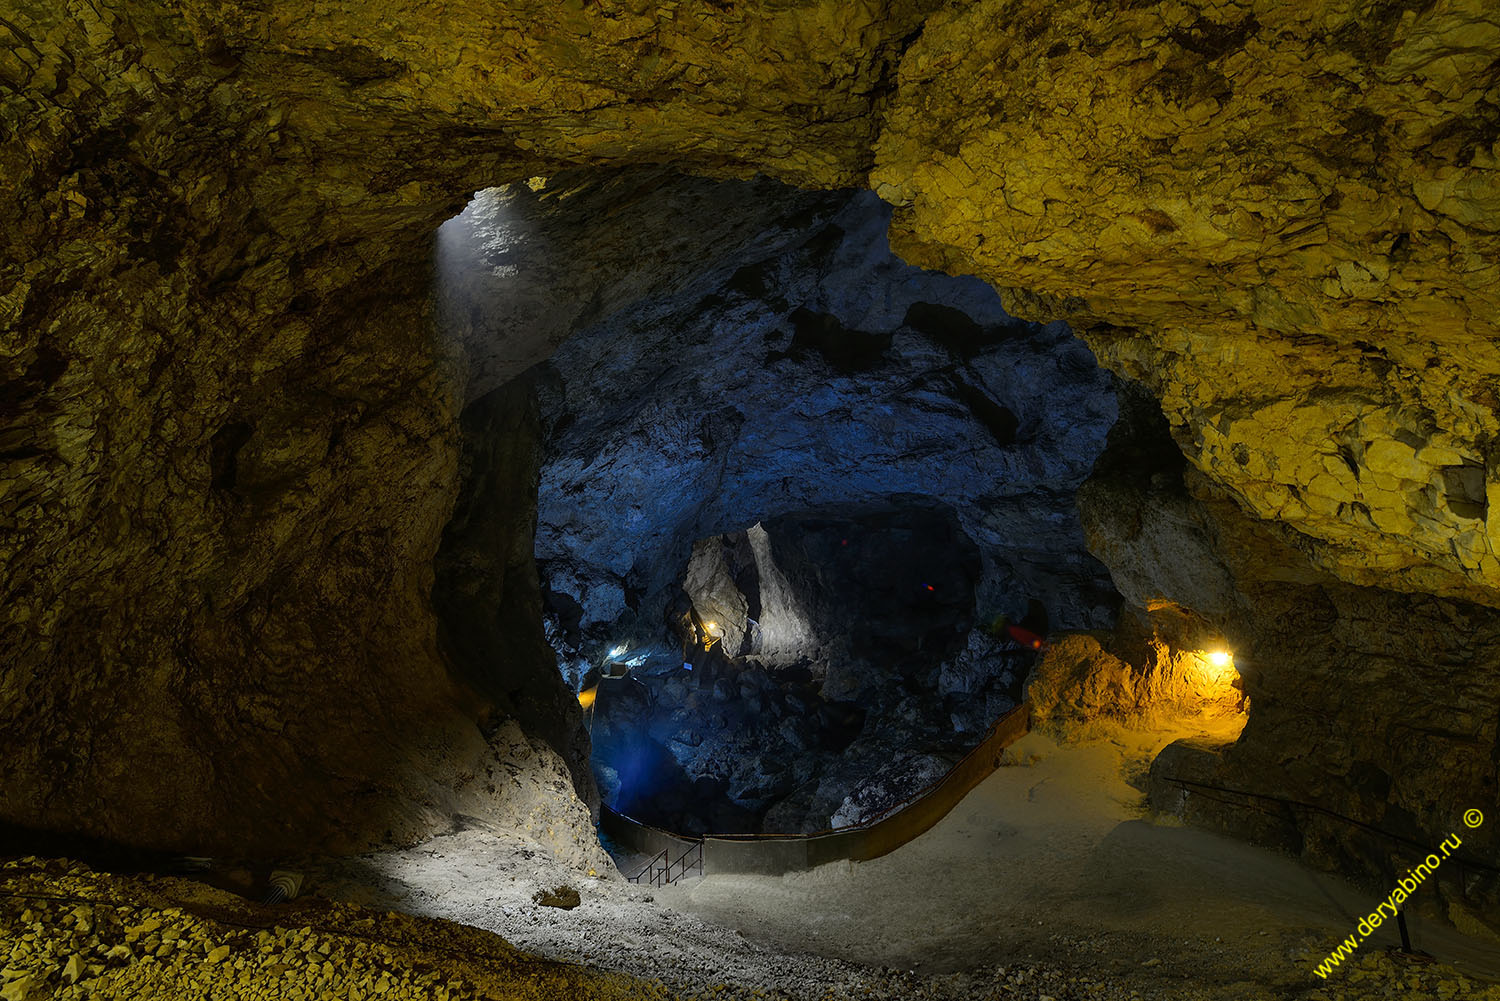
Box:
534, 182, 1116, 656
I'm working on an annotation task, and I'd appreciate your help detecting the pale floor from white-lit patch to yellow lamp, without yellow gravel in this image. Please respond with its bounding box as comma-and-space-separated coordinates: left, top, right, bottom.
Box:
298, 719, 1500, 1001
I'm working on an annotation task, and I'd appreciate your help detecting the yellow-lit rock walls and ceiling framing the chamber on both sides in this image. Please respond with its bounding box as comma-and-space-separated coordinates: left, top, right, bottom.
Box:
0, 0, 1500, 894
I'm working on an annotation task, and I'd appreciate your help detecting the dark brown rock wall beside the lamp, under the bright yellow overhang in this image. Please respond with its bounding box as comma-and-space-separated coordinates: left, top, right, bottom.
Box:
1086, 379, 1500, 920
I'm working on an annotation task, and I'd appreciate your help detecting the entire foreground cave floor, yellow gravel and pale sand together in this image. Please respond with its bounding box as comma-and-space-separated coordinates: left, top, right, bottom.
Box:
0, 717, 1500, 1001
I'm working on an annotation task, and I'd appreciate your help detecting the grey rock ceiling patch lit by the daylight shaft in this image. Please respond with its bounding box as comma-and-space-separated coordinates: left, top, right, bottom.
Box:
434, 168, 842, 399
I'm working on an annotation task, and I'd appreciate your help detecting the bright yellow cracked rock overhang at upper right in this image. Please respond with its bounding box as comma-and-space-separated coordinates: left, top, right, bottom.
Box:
872, 0, 1500, 605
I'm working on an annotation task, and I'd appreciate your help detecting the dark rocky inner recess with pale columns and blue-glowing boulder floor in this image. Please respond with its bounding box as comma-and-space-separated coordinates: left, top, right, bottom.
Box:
593, 498, 1008, 833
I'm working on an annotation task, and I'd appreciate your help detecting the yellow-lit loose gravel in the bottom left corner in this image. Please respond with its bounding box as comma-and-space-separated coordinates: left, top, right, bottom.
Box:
0, 858, 678, 1001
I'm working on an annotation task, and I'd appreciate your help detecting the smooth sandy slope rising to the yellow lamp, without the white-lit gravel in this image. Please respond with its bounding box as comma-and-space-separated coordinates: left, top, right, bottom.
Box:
660, 723, 1500, 996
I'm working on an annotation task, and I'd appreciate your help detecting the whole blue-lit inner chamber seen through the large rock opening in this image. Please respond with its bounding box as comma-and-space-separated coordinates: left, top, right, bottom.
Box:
486, 180, 1118, 831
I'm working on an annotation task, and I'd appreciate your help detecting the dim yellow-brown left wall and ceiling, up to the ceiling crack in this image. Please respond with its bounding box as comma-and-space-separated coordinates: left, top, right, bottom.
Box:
0, 0, 921, 852
